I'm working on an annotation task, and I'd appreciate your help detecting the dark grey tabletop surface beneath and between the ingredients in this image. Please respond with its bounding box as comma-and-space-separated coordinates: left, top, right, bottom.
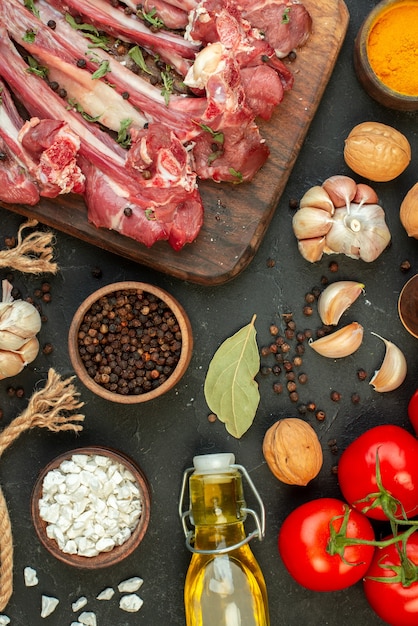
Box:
0, 0, 418, 626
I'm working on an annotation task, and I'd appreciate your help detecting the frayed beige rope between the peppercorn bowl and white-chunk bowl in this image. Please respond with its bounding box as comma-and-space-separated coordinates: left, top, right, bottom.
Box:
0, 368, 84, 611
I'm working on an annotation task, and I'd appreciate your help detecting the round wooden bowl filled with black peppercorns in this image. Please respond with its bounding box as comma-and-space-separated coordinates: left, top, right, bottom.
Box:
68, 281, 193, 404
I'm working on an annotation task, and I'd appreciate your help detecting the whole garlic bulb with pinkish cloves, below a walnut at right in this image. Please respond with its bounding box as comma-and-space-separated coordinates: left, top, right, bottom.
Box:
292, 176, 391, 263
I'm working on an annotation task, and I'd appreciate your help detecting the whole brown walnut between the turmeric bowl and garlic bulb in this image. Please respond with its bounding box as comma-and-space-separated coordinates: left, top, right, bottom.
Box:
344, 122, 411, 182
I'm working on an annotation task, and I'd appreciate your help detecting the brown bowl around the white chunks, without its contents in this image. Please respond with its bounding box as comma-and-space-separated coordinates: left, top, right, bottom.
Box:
31, 446, 151, 569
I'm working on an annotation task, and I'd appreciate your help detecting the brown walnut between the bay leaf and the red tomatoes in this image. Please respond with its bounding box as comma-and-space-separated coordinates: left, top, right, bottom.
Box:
263, 417, 323, 486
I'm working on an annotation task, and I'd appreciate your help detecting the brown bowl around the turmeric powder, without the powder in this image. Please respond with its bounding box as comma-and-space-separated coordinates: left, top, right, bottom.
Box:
354, 0, 418, 111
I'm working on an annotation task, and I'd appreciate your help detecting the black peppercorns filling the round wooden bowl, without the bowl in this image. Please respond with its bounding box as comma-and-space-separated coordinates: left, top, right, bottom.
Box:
77, 289, 182, 395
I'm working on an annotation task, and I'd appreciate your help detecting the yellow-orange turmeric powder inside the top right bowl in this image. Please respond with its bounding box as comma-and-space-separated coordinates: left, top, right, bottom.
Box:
367, 1, 418, 96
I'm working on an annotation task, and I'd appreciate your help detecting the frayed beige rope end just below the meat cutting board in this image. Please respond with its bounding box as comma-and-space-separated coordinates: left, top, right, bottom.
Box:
0, 220, 58, 274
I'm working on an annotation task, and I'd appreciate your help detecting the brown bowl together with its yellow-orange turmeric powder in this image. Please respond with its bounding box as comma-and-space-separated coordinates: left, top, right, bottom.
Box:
354, 0, 418, 111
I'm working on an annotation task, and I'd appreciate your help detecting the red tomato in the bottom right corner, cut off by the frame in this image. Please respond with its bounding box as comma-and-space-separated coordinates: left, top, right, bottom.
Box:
364, 531, 418, 626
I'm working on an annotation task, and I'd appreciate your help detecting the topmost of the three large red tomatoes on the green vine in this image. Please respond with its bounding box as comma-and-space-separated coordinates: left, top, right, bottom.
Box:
338, 425, 418, 520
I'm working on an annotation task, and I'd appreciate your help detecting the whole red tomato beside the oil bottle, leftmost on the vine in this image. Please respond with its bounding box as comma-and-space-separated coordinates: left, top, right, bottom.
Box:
278, 498, 374, 591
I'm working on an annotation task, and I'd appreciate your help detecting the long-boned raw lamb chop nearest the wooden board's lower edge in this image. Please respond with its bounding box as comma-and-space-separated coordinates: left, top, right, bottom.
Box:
0, 26, 203, 247
